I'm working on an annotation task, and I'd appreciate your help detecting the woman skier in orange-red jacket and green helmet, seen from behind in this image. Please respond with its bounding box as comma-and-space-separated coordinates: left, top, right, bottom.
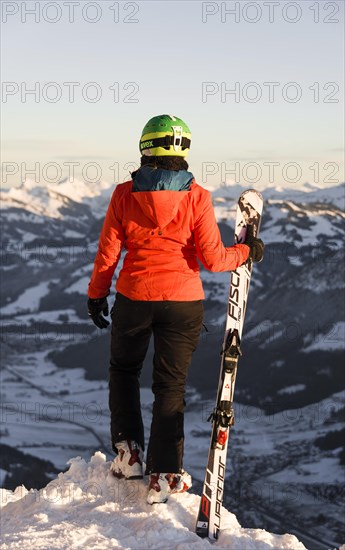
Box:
88, 115, 264, 504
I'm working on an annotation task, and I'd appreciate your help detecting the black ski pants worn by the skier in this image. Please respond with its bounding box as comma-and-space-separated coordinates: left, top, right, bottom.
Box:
109, 293, 203, 474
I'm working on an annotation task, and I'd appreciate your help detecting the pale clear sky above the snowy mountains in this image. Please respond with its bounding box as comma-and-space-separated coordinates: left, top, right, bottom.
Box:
1, 0, 344, 188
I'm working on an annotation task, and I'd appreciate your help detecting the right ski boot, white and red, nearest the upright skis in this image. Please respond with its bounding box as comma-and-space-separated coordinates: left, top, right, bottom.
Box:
147, 470, 192, 504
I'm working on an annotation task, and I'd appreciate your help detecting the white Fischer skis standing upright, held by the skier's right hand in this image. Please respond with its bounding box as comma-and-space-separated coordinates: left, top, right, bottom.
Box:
196, 189, 263, 540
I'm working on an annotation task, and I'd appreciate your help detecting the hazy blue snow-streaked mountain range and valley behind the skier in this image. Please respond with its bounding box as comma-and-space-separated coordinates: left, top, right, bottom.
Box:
0, 180, 345, 548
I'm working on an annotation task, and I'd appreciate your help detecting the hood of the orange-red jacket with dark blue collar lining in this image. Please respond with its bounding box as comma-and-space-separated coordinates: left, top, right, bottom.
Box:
132, 166, 193, 228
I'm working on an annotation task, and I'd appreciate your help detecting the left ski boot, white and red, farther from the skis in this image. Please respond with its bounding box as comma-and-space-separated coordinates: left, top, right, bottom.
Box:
110, 439, 144, 479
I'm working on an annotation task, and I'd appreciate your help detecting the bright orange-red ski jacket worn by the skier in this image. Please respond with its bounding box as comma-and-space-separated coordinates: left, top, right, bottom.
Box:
88, 174, 249, 301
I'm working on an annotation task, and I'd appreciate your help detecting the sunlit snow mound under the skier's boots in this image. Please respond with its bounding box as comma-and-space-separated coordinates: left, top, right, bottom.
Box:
0, 452, 305, 550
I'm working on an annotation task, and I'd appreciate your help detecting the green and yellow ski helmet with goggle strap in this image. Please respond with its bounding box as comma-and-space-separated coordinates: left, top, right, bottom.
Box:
139, 115, 191, 157
